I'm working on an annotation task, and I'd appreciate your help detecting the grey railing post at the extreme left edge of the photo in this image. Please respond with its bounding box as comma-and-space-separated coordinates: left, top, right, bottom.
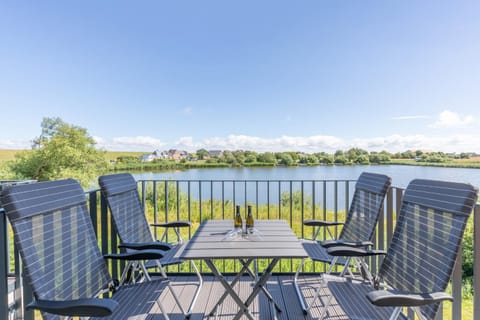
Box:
0, 208, 9, 319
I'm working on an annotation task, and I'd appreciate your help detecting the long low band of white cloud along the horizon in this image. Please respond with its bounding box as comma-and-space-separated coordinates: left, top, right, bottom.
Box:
0, 134, 480, 153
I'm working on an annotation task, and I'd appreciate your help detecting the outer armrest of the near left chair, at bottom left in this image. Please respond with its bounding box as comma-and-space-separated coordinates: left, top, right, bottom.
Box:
27, 298, 118, 317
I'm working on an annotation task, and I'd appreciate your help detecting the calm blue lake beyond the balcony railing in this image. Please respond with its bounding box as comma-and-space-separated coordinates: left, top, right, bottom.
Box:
133, 165, 480, 209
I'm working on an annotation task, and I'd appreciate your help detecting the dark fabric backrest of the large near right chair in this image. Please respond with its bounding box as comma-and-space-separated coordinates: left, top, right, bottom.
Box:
379, 179, 478, 319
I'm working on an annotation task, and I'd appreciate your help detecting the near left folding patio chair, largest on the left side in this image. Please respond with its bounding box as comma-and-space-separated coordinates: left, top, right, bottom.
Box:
1, 179, 182, 320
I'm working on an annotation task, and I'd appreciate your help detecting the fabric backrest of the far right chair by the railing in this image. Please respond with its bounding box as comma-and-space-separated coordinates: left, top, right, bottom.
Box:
338, 172, 392, 241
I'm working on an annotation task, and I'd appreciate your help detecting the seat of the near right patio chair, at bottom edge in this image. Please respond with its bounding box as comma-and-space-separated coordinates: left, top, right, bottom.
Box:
323, 274, 407, 320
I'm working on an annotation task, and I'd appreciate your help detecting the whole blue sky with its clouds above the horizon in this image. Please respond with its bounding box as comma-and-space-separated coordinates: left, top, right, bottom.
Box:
0, 0, 480, 152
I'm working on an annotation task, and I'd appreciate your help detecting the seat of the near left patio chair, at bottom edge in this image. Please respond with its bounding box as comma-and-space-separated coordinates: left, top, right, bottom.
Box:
90, 280, 168, 320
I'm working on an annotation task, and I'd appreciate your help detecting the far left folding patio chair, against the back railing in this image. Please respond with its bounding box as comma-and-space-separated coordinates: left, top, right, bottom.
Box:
98, 173, 203, 314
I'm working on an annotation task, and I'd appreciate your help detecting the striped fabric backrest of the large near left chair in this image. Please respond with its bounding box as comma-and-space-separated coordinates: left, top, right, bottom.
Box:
1, 179, 111, 319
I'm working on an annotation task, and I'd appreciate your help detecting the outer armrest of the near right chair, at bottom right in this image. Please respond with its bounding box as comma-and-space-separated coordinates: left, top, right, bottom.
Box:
367, 290, 453, 307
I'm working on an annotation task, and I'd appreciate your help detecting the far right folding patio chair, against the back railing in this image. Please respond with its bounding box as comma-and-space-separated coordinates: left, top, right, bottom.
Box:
294, 172, 391, 314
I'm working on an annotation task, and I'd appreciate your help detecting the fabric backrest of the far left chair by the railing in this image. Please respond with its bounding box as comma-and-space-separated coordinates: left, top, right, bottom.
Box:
98, 173, 154, 243
